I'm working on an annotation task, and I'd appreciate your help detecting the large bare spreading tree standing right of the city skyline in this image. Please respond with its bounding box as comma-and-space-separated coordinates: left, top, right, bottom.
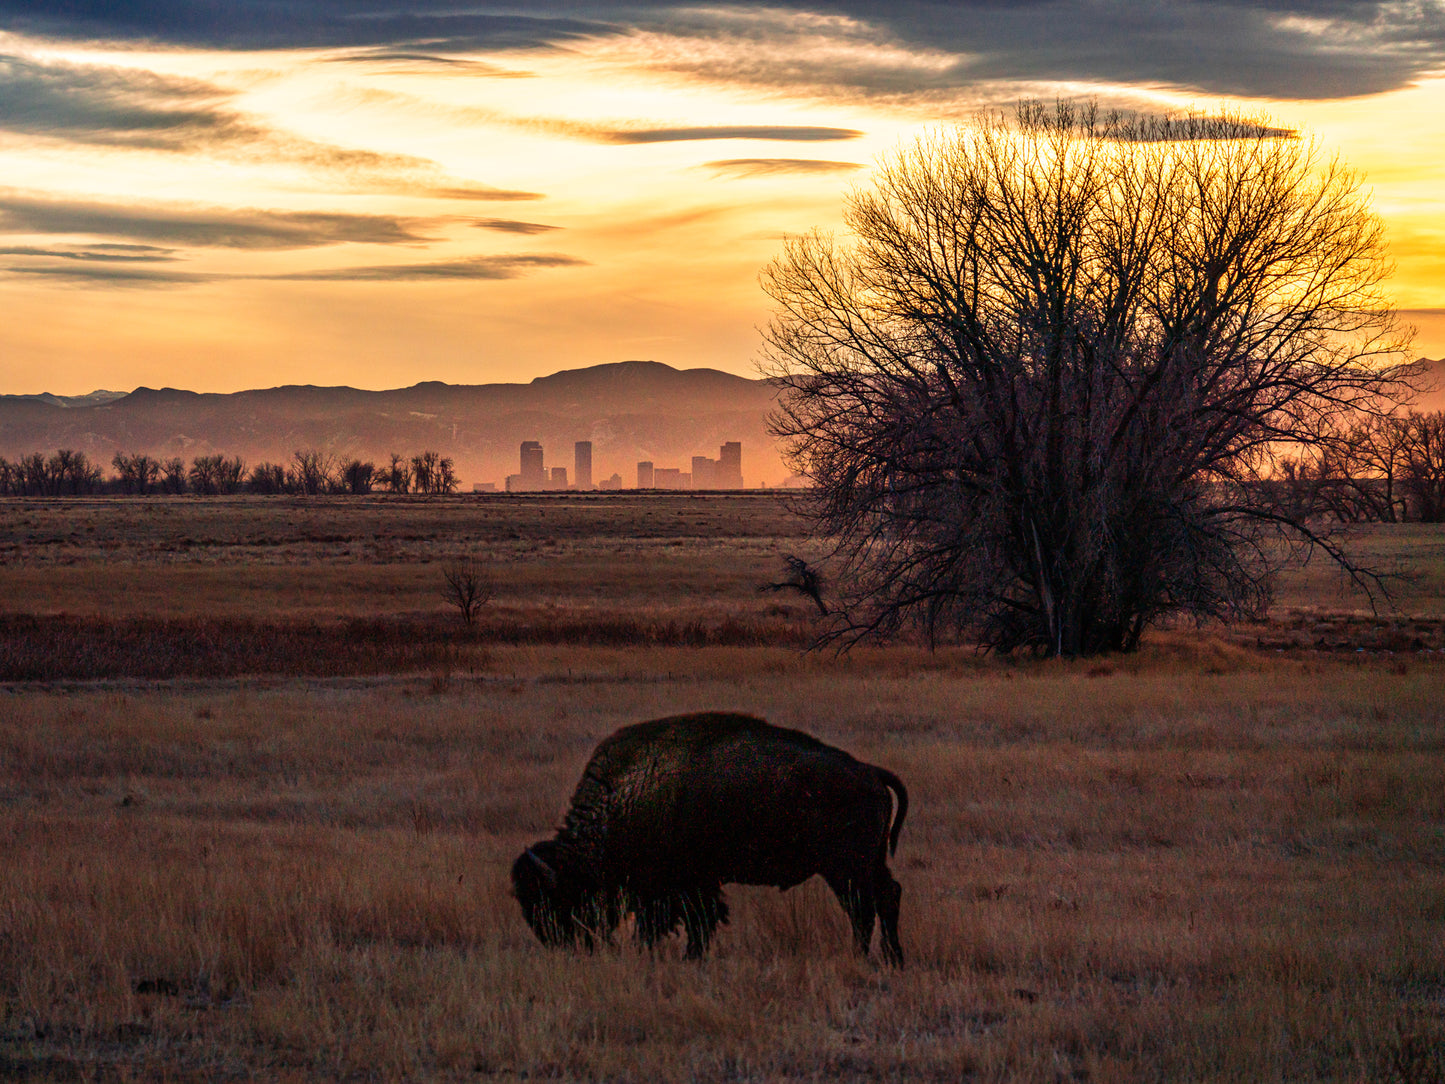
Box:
763, 106, 1406, 656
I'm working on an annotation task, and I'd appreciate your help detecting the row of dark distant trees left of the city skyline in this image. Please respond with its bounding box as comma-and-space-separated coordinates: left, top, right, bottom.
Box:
0, 448, 458, 497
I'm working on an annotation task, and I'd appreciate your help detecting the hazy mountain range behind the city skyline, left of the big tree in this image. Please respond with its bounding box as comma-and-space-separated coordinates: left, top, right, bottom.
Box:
0, 361, 788, 489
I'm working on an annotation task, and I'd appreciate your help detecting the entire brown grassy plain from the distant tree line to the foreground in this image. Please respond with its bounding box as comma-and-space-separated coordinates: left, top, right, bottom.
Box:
0, 494, 1445, 1084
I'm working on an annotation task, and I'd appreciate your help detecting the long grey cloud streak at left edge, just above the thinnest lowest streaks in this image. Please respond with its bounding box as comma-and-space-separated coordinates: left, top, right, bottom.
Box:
0, 192, 435, 249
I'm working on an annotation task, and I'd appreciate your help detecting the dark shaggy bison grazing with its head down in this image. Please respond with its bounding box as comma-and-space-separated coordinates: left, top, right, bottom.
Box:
512, 713, 907, 965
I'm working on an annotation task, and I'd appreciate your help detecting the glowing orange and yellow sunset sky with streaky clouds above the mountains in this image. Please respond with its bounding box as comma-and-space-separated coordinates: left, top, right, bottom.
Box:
0, 0, 1445, 395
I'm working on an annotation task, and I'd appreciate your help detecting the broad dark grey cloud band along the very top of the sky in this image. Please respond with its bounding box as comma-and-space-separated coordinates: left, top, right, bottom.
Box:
0, 0, 1445, 101
